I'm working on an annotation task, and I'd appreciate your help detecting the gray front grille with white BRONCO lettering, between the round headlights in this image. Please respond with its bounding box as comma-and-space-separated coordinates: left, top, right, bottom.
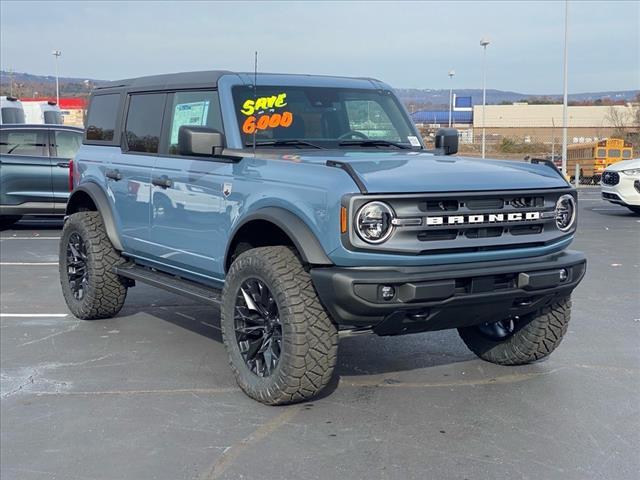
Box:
343, 189, 571, 255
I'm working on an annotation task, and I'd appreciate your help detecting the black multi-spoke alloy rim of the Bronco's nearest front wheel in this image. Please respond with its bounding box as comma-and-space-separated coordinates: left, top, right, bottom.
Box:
234, 278, 282, 377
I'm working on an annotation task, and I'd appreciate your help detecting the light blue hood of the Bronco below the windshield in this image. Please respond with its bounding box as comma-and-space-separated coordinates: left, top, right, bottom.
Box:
260, 150, 568, 193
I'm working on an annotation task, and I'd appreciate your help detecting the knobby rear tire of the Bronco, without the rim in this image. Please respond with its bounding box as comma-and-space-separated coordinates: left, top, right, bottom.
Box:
59, 212, 127, 320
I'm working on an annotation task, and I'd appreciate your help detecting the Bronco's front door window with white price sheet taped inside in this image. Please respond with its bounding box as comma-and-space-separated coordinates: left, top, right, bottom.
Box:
164, 91, 223, 155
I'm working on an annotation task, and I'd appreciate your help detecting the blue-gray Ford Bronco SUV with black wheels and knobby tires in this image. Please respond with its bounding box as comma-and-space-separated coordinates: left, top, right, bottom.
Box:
60, 71, 586, 404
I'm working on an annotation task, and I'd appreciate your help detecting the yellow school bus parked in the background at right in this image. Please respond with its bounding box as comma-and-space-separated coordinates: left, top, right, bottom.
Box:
567, 138, 633, 181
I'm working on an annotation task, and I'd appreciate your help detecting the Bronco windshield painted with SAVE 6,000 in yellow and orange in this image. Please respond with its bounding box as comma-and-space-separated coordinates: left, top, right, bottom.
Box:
233, 86, 422, 148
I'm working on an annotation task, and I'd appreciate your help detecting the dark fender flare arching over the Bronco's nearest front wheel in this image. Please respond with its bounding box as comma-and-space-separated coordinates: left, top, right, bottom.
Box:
224, 207, 333, 265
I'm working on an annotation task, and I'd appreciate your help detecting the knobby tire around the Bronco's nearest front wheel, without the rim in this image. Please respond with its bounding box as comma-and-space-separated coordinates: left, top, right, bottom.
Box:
221, 246, 338, 405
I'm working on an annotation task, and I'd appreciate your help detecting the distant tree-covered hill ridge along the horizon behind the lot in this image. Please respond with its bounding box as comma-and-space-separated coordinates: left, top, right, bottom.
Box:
0, 71, 640, 110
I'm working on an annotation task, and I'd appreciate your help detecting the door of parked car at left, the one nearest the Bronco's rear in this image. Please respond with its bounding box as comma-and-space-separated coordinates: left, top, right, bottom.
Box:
49, 129, 82, 210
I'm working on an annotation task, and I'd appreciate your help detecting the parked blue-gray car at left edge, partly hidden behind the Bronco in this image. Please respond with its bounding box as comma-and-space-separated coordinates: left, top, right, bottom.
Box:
0, 125, 83, 226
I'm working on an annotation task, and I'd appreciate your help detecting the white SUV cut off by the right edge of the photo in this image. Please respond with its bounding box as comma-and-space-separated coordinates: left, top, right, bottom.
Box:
600, 158, 640, 214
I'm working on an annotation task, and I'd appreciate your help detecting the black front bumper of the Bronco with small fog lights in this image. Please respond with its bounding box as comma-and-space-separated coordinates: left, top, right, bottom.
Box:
311, 250, 586, 335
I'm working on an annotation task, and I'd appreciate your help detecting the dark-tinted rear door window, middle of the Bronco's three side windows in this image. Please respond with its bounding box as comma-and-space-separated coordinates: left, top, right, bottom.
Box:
125, 93, 166, 153
